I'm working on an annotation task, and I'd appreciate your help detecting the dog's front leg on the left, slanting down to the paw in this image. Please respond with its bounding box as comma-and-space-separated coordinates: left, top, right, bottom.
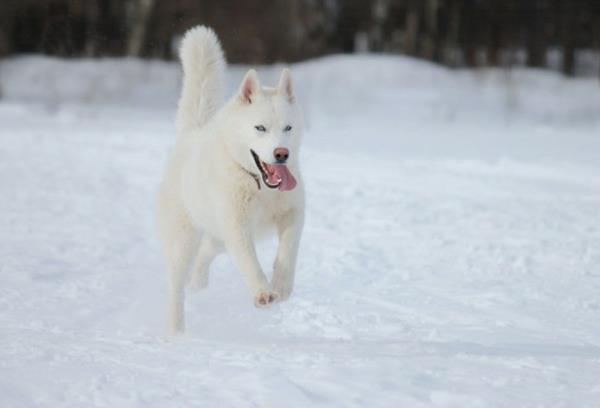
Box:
224, 225, 279, 307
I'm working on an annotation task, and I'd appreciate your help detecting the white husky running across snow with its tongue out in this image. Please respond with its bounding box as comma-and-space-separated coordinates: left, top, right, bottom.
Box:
157, 27, 304, 332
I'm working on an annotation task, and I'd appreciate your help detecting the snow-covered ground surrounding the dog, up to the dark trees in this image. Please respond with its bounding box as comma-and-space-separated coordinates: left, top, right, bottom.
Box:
0, 56, 600, 408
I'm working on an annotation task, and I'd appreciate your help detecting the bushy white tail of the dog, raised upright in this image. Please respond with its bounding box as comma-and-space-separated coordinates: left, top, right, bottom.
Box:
176, 26, 226, 134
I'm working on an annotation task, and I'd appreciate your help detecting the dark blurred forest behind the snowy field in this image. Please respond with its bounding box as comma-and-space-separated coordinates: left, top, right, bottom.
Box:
0, 0, 600, 75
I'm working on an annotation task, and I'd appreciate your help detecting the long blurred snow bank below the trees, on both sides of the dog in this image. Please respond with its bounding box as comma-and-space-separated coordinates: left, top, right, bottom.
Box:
0, 55, 600, 123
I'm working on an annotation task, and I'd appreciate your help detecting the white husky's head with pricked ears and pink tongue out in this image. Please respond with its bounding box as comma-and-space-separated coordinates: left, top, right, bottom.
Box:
227, 69, 302, 191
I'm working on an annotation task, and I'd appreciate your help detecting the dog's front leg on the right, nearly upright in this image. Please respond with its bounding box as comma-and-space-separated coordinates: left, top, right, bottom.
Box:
273, 209, 304, 300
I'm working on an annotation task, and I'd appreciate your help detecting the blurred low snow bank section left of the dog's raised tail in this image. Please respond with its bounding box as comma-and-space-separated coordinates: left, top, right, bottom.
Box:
0, 56, 180, 107
